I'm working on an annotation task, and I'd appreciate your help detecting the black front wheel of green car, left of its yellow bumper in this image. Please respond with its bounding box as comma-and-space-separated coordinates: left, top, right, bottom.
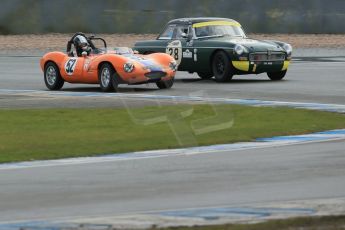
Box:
212, 51, 234, 82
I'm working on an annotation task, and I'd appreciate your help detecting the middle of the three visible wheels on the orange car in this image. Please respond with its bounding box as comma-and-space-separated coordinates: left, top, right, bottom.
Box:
98, 63, 118, 92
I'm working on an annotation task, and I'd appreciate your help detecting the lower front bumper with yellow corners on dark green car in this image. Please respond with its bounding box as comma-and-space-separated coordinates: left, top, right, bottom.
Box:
232, 61, 290, 74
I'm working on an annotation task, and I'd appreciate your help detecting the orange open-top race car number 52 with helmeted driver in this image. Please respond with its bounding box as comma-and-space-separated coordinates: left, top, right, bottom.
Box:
40, 33, 177, 92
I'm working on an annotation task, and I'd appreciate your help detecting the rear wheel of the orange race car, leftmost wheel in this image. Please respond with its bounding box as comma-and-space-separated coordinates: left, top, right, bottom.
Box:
44, 62, 65, 90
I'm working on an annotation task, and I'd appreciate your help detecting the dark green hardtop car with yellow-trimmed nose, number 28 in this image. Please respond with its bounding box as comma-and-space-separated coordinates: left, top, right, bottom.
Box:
134, 18, 292, 82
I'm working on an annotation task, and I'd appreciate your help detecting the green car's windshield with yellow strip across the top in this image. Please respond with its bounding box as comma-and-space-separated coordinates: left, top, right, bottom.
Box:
193, 21, 246, 38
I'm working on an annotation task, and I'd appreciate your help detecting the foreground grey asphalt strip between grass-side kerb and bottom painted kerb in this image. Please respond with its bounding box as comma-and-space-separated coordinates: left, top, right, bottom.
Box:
0, 141, 345, 221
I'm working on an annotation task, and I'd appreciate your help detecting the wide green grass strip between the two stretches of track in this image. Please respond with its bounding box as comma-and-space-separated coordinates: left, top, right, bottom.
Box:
0, 105, 345, 163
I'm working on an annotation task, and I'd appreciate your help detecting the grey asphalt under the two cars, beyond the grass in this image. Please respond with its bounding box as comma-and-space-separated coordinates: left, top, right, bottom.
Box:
0, 53, 345, 107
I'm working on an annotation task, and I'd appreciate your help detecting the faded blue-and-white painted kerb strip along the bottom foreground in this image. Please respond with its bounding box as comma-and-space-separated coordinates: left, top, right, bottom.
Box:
0, 199, 345, 230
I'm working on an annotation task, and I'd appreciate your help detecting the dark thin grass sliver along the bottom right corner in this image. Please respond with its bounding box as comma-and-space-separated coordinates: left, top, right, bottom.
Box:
155, 216, 345, 230
